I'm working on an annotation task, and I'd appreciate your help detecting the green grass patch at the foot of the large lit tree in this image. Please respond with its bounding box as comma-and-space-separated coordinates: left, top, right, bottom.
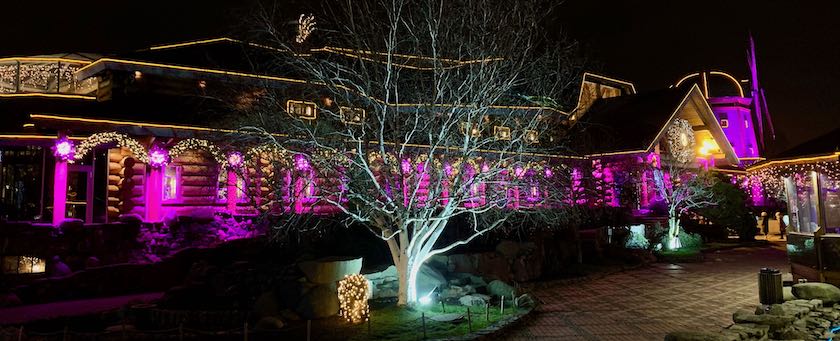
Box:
350, 302, 524, 341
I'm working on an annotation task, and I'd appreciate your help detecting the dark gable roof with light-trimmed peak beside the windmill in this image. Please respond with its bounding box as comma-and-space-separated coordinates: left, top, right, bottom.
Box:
569, 86, 738, 164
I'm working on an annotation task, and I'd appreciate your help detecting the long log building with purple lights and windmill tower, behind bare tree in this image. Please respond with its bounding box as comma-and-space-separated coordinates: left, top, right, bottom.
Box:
0, 38, 763, 274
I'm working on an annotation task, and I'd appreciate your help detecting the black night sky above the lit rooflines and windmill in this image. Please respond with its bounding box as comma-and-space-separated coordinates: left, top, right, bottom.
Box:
0, 0, 840, 151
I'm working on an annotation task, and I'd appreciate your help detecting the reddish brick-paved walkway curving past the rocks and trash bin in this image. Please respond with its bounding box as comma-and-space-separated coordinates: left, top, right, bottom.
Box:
505, 247, 790, 341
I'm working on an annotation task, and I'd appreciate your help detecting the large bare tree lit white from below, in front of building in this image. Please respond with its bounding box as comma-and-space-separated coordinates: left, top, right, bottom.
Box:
243, 0, 581, 305
